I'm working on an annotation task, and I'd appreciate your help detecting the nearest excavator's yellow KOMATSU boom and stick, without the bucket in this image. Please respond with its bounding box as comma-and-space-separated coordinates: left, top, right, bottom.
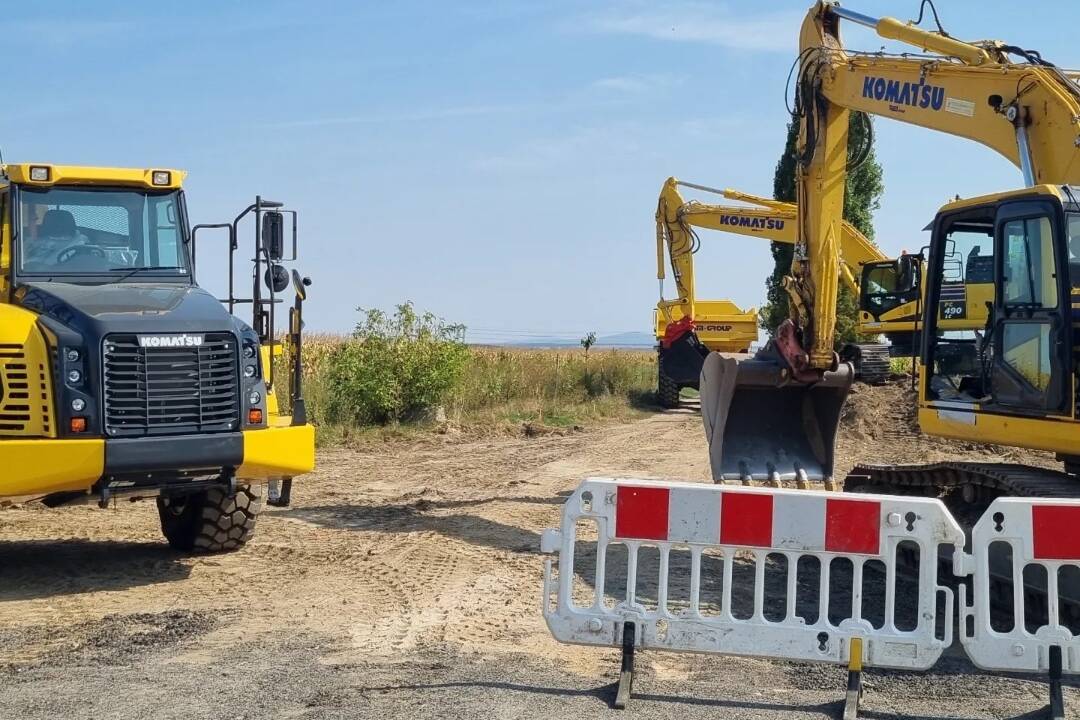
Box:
784, 2, 1080, 375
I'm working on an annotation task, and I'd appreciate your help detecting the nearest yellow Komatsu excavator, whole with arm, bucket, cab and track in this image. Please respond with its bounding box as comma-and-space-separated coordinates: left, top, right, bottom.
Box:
701, 2, 1080, 507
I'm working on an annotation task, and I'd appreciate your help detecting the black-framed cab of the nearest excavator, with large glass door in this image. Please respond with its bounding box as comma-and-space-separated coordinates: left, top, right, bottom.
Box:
919, 186, 1080, 446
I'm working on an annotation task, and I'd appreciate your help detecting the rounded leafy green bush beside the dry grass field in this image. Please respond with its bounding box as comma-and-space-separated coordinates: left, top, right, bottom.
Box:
319, 302, 469, 425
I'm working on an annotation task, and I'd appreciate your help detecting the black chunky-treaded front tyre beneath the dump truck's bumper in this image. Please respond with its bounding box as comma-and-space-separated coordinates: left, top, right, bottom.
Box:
158, 485, 266, 553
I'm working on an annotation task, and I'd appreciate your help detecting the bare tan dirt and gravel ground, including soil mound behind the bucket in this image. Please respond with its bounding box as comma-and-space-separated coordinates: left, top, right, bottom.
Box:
0, 389, 1080, 720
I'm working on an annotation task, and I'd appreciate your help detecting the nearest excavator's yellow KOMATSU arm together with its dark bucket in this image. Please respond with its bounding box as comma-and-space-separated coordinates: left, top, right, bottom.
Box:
701, 0, 1080, 487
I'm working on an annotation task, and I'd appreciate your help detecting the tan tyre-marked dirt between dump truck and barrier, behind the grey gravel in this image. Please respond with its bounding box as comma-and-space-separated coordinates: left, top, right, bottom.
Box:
0, 415, 705, 669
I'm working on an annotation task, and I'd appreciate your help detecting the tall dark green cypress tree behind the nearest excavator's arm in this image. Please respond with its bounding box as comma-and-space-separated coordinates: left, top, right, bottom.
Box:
758, 112, 885, 347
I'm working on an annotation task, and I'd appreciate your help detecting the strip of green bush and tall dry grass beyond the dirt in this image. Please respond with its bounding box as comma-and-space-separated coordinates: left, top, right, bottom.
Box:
291, 303, 657, 433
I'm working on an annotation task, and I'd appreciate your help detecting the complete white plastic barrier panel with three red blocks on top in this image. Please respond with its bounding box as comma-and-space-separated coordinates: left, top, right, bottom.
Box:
542, 478, 963, 669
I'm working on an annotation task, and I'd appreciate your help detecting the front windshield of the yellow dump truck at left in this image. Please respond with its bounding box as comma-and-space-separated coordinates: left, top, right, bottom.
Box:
18, 187, 188, 276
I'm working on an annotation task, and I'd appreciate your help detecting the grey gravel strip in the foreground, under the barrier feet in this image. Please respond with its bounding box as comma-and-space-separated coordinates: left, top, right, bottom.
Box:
0, 616, 1080, 720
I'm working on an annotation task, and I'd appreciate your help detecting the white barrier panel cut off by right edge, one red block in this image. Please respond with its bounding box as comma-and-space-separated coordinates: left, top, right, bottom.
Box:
960, 498, 1080, 677
